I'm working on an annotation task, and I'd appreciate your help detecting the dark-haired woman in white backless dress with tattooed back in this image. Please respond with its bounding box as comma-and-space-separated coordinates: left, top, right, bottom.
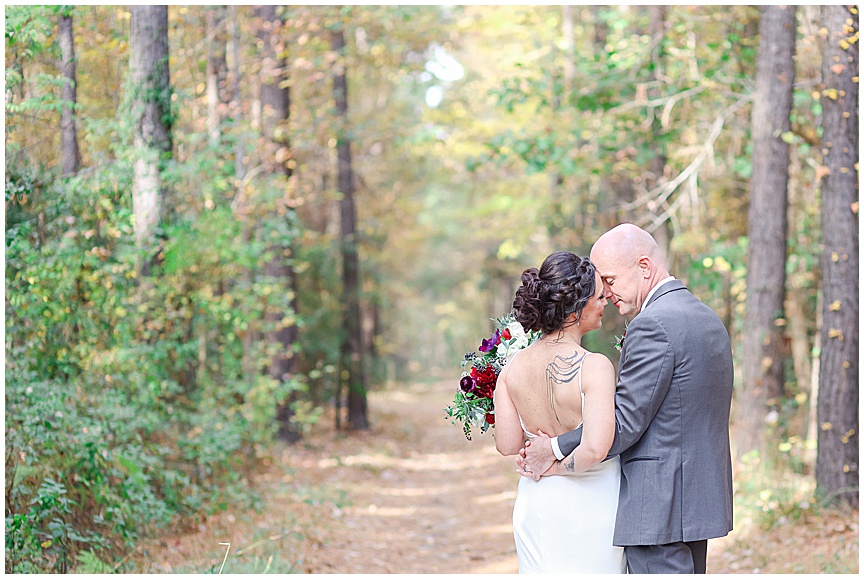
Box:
495, 251, 626, 573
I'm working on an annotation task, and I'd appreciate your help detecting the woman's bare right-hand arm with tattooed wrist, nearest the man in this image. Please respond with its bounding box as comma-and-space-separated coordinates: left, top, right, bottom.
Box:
544, 355, 615, 476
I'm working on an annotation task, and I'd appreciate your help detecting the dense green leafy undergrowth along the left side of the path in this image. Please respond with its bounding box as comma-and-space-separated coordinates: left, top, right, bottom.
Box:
5, 157, 315, 572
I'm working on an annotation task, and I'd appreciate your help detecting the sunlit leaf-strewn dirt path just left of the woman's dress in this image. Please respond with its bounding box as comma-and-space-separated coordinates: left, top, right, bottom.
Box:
284, 383, 518, 573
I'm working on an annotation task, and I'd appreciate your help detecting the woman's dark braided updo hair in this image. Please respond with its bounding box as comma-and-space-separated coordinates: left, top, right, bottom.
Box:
513, 251, 596, 334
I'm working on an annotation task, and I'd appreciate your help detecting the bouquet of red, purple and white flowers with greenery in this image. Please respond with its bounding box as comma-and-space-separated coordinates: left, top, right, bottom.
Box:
445, 313, 541, 440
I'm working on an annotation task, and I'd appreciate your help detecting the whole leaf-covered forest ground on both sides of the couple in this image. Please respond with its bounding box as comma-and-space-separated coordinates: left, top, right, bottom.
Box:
131, 382, 859, 574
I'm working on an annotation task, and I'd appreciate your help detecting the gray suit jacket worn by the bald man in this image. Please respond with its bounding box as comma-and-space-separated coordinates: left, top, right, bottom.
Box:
558, 280, 733, 546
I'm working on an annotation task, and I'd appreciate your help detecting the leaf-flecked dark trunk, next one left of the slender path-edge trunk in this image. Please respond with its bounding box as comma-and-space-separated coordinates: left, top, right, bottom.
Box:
258, 5, 299, 441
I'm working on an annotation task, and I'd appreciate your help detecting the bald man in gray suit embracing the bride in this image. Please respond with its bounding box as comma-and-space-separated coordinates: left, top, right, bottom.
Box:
517, 224, 733, 573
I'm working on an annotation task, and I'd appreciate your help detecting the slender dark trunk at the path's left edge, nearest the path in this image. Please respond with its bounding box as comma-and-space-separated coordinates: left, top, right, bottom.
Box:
330, 27, 369, 430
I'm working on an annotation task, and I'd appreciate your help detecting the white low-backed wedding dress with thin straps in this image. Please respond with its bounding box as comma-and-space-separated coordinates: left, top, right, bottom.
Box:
513, 364, 627, 573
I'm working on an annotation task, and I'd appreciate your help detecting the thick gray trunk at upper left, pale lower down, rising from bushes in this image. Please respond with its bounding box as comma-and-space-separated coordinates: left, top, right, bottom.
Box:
129, 6, 172, 275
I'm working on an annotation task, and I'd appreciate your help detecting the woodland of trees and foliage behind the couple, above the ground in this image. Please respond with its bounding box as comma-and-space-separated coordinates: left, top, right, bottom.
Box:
5, 6, 859, 572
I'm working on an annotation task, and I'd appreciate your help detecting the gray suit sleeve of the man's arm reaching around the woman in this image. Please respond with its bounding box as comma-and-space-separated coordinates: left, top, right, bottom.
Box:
558, 314, 675, 458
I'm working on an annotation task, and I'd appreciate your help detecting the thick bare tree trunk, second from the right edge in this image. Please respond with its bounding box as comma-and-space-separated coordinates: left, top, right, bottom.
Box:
737, 6, 795, 455
